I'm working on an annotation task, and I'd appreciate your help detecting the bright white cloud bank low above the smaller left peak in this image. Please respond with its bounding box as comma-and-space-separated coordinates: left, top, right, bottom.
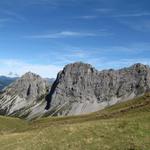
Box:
0, 59, 62, 78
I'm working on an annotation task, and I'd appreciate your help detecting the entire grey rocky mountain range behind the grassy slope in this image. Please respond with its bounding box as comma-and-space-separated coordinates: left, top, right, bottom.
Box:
0, 62, 150, 120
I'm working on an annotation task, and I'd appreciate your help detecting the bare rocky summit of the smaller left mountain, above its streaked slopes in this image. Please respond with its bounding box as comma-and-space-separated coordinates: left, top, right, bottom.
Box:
5, 72, 49, 100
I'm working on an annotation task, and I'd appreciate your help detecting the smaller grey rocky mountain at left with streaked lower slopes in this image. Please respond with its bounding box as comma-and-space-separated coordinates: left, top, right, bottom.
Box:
0, 72, 50, 119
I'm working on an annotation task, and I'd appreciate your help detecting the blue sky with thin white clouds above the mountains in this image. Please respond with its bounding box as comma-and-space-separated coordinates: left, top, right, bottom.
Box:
0, 0, 150, 77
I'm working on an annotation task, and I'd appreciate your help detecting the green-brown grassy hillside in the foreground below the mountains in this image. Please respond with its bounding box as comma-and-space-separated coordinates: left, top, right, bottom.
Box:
0, 94, 150, 150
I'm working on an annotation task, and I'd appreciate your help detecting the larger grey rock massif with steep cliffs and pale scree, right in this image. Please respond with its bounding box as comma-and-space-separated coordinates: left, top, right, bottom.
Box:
46, 63, 150, 115
